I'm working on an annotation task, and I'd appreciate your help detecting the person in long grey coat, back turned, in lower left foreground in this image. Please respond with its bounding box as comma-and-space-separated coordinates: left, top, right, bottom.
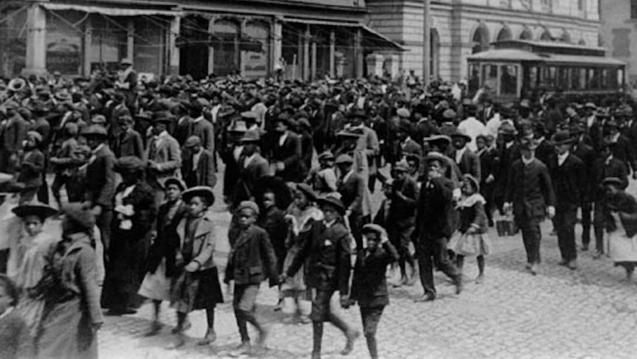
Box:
36, 203, 103, 359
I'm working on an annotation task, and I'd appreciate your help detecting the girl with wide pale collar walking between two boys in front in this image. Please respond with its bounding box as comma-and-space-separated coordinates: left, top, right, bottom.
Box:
281, 183, 323, 324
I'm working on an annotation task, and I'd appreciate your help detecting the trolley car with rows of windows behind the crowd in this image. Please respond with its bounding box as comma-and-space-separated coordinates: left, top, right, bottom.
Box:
467, 40, 625, 102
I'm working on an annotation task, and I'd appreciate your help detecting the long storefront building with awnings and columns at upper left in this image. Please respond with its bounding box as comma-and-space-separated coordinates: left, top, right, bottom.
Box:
0, 0, 403, 79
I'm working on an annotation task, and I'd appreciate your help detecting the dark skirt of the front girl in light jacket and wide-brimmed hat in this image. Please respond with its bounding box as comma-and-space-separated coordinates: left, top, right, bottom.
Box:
170, 267, 223, 313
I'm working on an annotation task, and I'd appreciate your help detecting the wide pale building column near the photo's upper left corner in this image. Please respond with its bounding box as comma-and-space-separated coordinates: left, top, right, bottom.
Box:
22, 2, 47, 76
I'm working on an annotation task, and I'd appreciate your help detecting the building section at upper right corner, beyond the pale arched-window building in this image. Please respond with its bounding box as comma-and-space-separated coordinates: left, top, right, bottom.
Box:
600, 0, 637, 83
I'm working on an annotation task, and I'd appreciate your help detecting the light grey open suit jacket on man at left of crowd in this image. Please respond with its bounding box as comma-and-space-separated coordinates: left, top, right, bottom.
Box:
147, 133, 181, 188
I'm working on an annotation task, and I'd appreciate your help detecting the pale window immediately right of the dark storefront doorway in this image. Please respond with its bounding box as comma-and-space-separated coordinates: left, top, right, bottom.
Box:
212, 19, 240, 76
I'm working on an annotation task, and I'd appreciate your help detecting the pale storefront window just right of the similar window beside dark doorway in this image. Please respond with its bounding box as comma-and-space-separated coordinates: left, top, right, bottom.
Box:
240, 22, 270, 77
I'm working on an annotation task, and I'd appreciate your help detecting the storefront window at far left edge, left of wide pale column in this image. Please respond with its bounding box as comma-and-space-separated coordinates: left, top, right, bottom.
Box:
0, 7, 27, 77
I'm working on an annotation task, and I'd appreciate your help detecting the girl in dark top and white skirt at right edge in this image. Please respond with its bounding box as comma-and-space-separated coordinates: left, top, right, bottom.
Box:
602, 177, 637, 281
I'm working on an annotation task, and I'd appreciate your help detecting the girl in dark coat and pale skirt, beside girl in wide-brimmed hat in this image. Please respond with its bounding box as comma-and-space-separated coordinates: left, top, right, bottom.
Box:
139, 178, 187, 336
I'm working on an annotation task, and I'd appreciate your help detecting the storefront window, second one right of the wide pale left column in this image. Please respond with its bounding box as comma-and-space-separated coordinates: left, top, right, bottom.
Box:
87, 15, 128, 71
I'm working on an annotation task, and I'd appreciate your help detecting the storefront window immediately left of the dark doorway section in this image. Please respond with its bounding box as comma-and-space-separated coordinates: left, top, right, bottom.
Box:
133, 17, 166, 74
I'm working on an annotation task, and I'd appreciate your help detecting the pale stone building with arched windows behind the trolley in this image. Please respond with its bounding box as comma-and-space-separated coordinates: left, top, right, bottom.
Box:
367, 0, 600, 81
